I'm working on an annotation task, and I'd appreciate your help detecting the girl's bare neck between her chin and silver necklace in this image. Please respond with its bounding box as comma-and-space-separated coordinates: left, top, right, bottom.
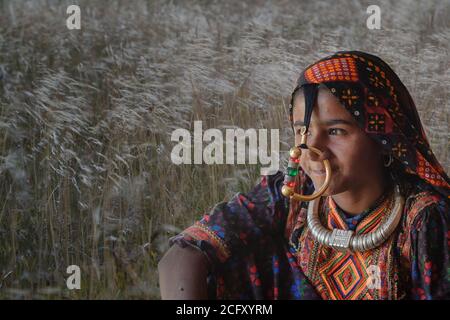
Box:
331, 172, 388, 216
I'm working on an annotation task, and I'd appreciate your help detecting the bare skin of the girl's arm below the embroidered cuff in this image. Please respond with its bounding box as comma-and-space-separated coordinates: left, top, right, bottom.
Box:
158, 244, 208, 300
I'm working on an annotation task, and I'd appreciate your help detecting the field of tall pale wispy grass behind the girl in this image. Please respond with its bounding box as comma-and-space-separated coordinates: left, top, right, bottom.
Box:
0, 0, 450, 299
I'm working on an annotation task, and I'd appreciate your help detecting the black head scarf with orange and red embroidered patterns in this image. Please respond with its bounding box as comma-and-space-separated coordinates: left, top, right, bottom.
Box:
290, 51, 450, 198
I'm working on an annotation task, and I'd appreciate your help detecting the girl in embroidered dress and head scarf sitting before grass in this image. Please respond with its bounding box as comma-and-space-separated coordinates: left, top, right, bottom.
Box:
159, 51, 450, 299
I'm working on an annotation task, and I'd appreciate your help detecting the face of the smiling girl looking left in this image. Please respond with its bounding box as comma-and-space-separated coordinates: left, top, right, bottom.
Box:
293, 88, 383, 195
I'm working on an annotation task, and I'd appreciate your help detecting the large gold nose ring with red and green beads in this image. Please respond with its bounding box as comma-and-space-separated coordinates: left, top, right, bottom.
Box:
281, 147, 331, 201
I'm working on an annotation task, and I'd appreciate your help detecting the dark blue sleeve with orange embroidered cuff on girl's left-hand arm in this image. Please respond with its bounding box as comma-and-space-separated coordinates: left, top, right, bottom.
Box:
170, 172, 285, 263
